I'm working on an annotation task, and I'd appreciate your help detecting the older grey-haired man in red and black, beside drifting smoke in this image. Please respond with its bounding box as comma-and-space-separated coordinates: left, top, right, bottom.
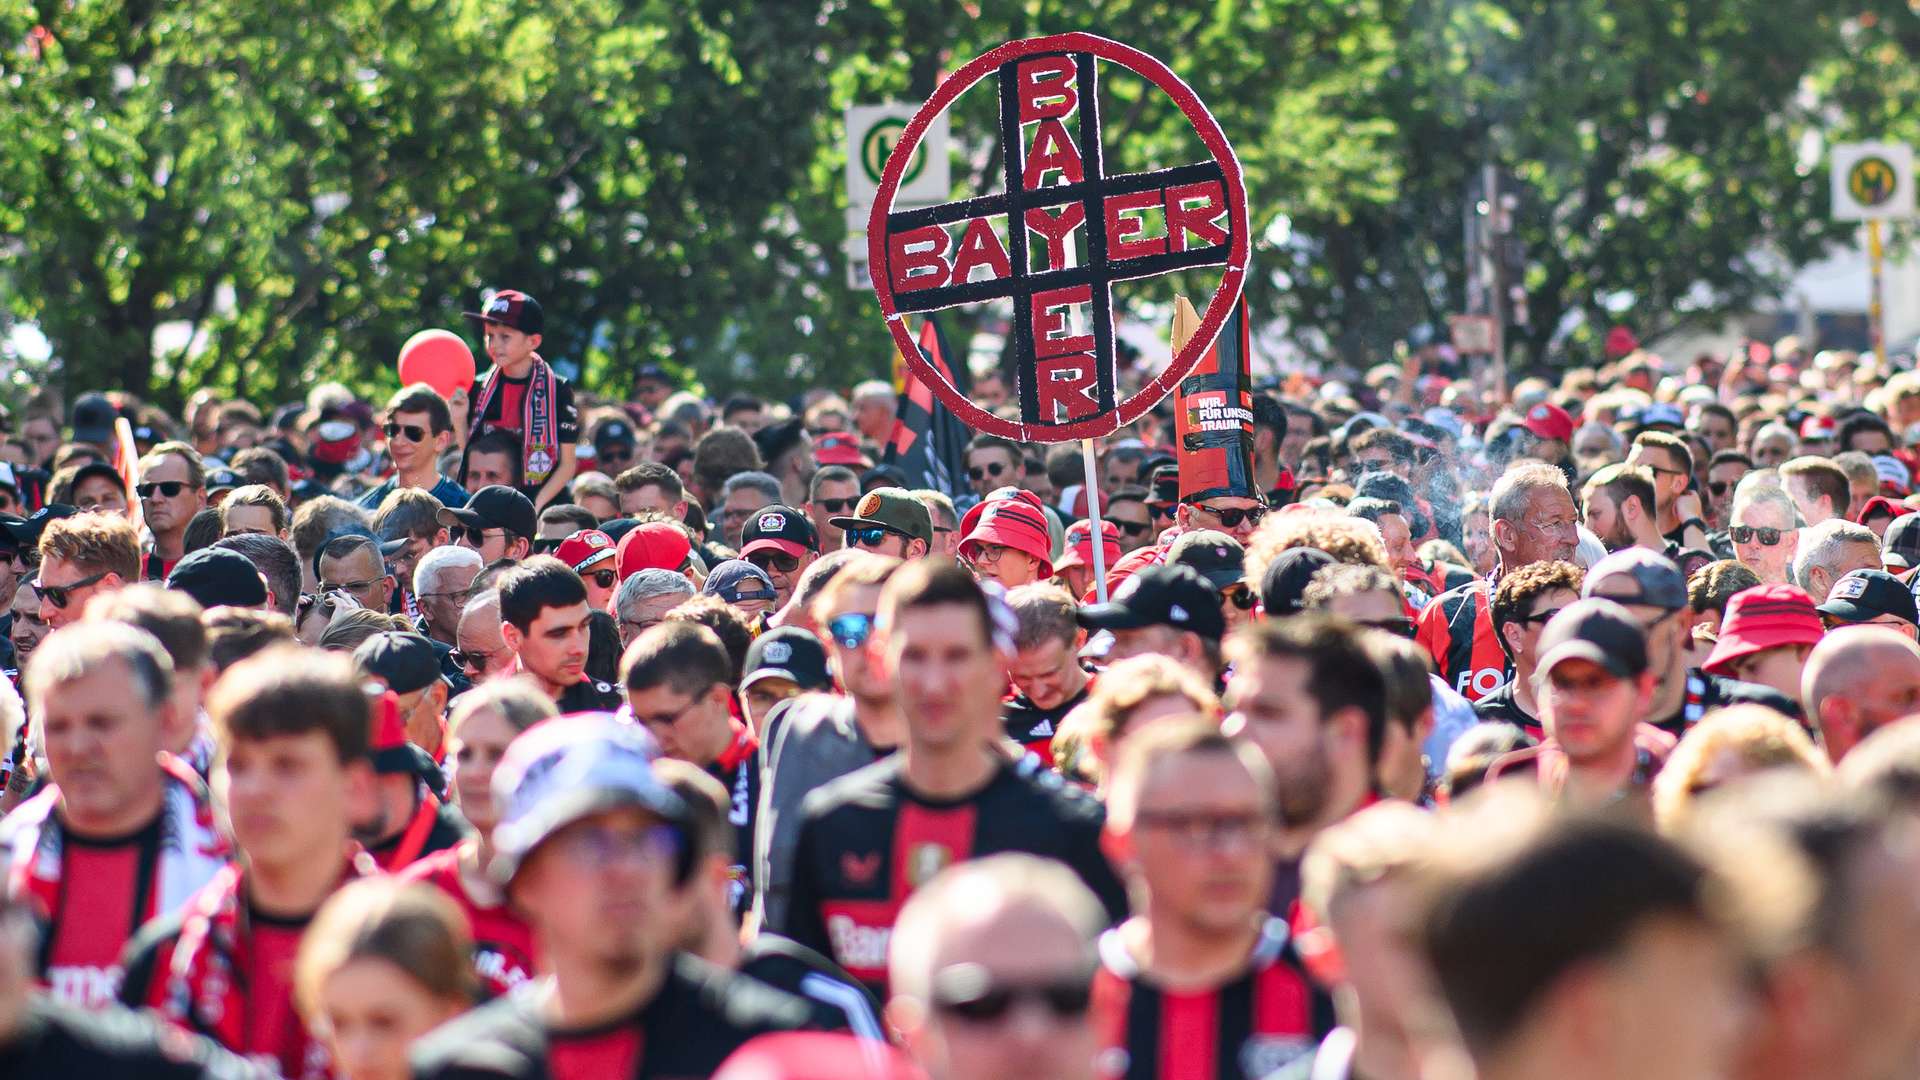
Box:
1415, 461, 1580, 701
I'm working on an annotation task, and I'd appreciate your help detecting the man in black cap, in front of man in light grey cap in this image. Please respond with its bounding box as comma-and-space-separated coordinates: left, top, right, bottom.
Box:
1486, 598, 1674, 807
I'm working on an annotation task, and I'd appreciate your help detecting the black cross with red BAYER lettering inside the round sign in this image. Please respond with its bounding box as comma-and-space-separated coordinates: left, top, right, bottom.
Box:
874, 50, 1244, 440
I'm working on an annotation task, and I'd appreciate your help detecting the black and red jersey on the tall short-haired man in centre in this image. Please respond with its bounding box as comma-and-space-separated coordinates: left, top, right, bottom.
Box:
772, 755, 1127, 997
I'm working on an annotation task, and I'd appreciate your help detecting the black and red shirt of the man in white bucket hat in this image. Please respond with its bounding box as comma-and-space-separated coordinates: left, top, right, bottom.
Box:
413, 957, 812, 1080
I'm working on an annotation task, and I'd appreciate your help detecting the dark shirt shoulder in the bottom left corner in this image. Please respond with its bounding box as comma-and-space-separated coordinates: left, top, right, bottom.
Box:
0, 994, 265, 1080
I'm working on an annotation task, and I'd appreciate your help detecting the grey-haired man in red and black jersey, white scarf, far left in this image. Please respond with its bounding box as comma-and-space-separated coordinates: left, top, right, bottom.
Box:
0, 623, 227, 1007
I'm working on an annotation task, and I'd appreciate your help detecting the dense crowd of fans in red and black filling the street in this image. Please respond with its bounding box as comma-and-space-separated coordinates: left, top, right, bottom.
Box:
0, 290, 1920, 1080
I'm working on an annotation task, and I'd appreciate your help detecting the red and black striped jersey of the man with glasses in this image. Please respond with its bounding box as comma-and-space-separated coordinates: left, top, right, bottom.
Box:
1092, 919, 1334, 1080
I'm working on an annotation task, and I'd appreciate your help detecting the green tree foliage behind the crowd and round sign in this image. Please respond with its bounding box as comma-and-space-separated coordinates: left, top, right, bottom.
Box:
0, 0, 1920, 404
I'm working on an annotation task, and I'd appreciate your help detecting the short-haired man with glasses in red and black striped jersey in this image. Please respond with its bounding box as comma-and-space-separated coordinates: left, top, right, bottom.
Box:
1094, 717, 1332, 1080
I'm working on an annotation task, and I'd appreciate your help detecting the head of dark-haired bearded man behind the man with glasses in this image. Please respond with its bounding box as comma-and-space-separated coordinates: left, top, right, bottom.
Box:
1221, 615, 1386, 915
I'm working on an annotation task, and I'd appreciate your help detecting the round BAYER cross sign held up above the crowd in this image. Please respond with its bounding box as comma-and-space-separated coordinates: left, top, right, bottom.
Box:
868, 33, 1250, 442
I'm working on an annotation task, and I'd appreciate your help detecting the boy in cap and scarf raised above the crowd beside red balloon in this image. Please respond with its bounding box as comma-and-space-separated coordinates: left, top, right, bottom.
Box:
465, 288, 580, 509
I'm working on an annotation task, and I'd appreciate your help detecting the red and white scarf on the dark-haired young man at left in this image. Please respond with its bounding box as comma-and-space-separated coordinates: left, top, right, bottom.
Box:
156, 846, 380, 1080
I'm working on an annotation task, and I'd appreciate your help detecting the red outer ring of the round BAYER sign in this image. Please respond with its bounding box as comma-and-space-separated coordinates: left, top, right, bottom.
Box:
866, 33, 1252, 442
